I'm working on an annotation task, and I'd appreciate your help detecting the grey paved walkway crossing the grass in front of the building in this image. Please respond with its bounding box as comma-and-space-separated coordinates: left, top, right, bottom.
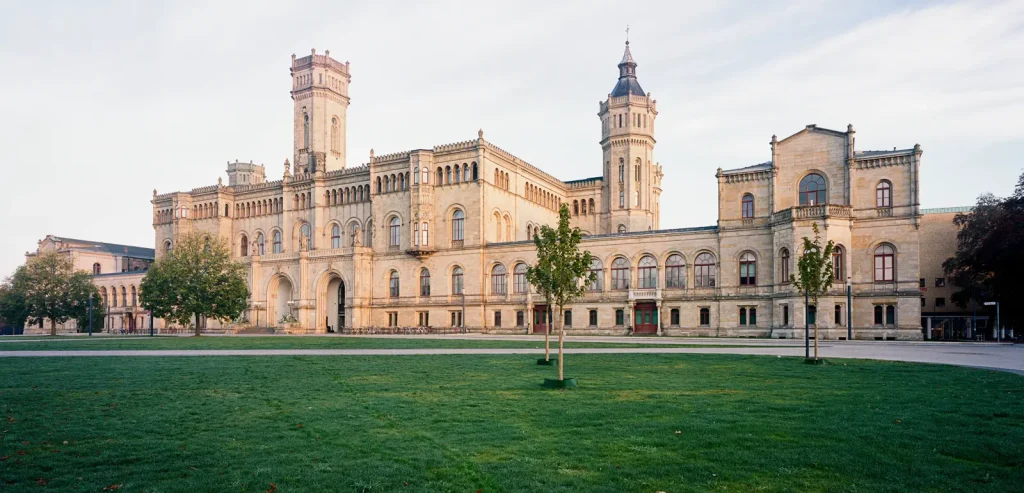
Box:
0, 335, 1024, 375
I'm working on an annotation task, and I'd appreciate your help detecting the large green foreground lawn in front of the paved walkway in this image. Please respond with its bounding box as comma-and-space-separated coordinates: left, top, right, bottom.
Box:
0, 352, 1024, 487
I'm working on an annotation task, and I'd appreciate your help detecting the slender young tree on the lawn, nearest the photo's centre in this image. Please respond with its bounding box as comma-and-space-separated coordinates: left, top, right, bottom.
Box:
526, 204, 595, 380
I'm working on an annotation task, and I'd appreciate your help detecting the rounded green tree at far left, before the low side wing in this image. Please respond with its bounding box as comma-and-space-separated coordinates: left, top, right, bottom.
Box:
8, 251, 96, 335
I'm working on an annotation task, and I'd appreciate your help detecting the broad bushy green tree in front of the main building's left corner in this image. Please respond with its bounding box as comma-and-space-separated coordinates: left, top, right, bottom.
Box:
139, 234, 249, 336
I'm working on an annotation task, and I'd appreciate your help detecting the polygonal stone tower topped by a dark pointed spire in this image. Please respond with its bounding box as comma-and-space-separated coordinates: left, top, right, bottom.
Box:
597, 39, 663, 233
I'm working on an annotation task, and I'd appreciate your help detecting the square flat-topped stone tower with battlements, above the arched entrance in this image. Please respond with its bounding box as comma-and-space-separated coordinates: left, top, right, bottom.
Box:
291, 49, 352, 173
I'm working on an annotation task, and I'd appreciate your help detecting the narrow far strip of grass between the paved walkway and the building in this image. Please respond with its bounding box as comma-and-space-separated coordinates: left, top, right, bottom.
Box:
0, 335, 774, 351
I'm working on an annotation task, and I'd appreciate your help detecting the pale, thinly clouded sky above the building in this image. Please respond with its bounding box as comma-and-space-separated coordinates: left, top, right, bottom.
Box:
0, 0, 1024, 277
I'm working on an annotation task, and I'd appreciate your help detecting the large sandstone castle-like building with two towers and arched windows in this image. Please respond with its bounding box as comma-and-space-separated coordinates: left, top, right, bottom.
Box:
153, 43, 937, 339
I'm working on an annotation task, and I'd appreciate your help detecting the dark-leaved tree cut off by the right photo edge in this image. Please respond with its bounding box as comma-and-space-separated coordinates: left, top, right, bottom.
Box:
942, 170, 1024, 327
